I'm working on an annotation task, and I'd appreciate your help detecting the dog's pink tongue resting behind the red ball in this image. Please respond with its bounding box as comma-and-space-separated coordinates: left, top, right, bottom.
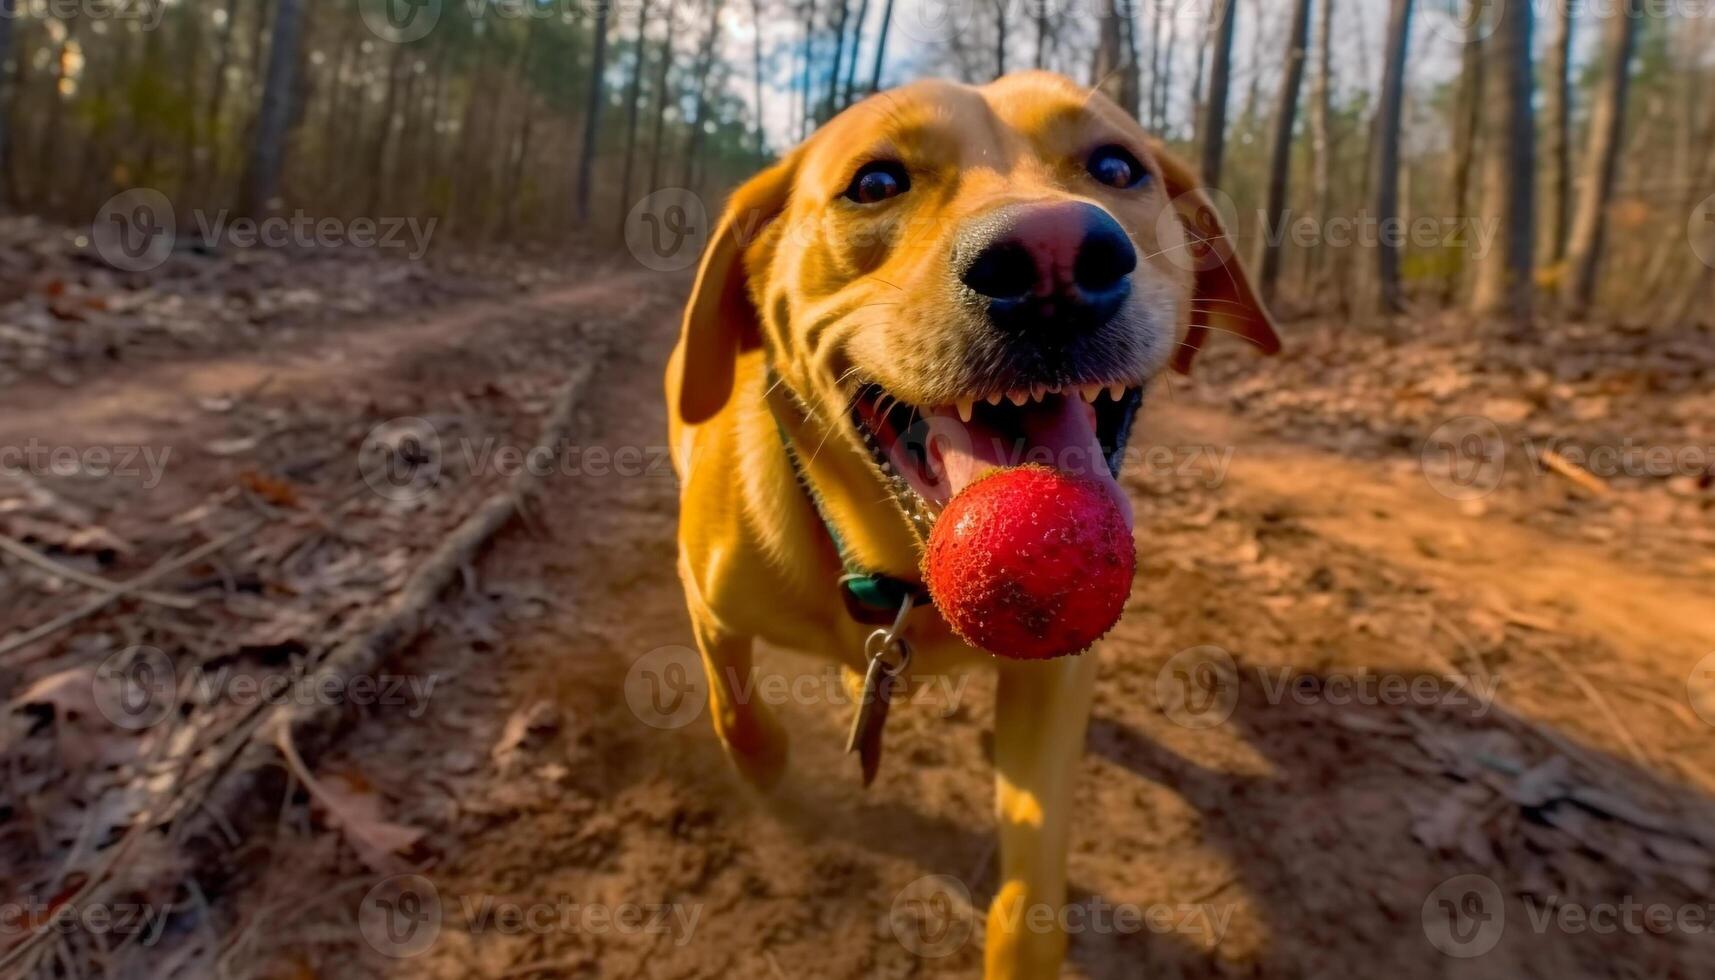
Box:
919, 395, 1132, 525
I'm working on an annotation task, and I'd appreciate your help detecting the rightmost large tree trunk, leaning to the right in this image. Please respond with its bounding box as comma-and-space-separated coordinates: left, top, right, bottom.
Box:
1566, 0, 1640, 314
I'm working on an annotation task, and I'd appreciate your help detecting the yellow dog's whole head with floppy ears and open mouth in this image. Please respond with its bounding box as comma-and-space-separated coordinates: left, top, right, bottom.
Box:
677, 72, 1279, 528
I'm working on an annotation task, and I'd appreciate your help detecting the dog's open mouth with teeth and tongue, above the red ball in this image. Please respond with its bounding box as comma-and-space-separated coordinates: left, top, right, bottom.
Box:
852, 381, 1144, 523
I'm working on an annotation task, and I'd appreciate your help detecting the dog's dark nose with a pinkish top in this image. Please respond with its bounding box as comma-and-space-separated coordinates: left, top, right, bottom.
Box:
959, 201, 1137, 330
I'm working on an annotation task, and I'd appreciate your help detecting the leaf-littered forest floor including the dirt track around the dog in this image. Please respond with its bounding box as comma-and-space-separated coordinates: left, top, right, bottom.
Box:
0, 224, 1715, 980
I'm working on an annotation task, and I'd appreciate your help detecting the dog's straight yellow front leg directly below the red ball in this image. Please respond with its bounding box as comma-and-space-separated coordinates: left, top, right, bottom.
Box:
983, 654, 1096, 980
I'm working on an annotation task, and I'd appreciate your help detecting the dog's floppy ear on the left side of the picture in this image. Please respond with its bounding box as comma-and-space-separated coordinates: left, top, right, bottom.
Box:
679, 153, 797, 426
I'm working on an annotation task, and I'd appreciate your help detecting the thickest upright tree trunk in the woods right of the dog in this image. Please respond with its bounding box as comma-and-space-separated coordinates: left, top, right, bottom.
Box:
1471, 3, 1537, 331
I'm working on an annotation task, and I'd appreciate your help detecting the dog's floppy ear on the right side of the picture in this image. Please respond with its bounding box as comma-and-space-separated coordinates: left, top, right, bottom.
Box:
1151, 142, 1281, 374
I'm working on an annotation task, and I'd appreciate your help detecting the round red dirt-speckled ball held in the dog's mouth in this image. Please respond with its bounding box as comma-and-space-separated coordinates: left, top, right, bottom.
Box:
923, 465, 1137, 661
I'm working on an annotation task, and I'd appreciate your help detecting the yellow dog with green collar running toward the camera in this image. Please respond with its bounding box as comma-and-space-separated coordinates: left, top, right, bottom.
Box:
665, 72, 1279, 980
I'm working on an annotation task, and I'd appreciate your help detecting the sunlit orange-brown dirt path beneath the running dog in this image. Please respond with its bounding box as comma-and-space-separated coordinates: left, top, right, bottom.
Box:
187, 298, 1715, 980
